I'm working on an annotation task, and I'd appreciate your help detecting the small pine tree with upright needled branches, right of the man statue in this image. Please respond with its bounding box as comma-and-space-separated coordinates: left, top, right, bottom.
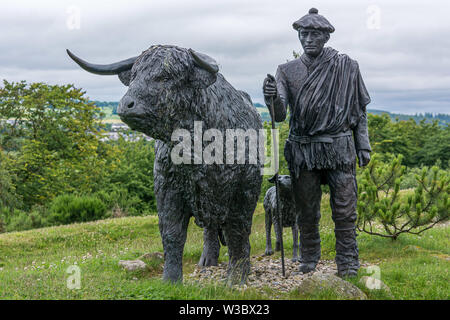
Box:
358, 155, 450, 240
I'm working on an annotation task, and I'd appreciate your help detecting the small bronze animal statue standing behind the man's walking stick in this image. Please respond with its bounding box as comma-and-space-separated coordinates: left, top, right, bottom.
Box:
264, 175, 299, 262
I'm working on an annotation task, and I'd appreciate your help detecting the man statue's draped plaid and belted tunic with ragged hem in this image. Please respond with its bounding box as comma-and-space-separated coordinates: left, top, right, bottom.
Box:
266, 48, 371, 176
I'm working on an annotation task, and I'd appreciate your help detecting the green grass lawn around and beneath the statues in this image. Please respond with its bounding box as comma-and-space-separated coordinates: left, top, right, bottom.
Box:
0, 196, 450, 299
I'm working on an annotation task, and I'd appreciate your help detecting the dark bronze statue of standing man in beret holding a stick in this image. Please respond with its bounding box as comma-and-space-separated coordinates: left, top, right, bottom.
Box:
263, 8, 371, 276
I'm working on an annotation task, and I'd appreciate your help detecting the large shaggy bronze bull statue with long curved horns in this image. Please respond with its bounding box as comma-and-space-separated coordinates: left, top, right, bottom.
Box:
68, 45, 263, 283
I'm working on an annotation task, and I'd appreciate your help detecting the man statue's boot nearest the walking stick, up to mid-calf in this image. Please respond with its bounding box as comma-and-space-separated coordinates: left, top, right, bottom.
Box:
299, 224, 320, 273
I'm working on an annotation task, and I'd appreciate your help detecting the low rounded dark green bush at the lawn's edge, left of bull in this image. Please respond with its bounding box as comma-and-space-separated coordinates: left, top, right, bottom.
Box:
49, 194, 107, 225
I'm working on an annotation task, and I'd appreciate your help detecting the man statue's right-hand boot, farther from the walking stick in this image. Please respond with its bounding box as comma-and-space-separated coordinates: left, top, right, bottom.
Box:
334, 227, 359, 277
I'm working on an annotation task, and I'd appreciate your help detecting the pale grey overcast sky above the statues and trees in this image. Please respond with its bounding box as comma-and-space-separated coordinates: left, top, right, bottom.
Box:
0, 0, 450, 114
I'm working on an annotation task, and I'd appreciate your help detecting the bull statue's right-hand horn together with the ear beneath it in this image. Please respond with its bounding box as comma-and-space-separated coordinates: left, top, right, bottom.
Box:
189, 49, 219, 89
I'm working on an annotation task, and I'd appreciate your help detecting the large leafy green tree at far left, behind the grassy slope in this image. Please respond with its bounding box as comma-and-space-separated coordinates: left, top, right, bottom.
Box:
0, 81, 106, 208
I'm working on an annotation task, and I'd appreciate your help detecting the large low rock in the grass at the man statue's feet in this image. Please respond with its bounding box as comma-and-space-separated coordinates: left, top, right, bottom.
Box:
298, 273, 367, 300
